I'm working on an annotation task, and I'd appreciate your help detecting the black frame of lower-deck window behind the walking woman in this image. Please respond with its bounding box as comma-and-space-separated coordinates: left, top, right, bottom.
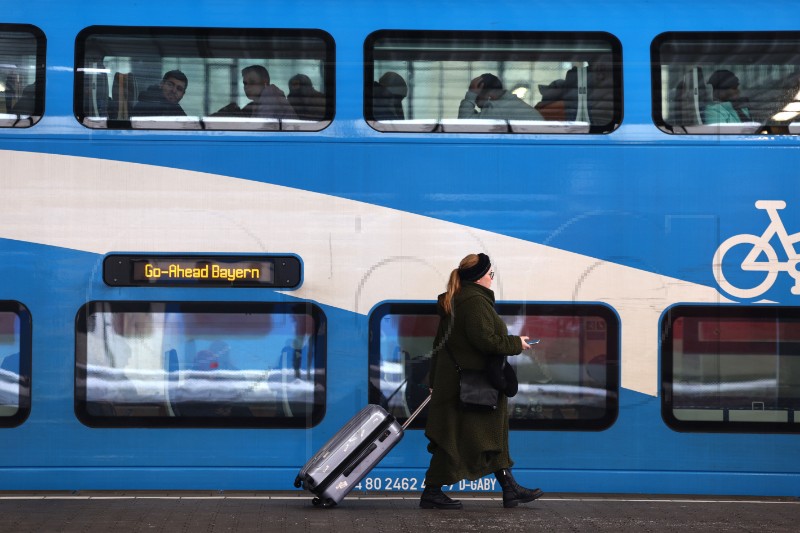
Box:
367, 301, 621, 431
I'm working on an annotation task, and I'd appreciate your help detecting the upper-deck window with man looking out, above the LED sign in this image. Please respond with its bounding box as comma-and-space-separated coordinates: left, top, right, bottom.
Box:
74, 26, 335, 131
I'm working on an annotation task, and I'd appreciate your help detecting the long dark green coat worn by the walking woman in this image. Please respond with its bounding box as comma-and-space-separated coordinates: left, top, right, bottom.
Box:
425, 282, 522, 486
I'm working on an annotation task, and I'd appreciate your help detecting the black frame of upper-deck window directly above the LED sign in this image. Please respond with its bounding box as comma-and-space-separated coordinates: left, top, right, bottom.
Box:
72, 25, 336, 133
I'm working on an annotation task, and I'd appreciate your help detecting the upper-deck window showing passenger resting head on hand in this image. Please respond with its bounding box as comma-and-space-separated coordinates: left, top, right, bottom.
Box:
364, 31, 622, 133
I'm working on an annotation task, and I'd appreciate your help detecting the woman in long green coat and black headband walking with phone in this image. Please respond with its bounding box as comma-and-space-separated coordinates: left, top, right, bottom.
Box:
420, 253, 543, 509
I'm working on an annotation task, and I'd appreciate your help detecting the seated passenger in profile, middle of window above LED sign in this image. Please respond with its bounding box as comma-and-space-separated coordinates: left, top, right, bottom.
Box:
215, 65, 297, 119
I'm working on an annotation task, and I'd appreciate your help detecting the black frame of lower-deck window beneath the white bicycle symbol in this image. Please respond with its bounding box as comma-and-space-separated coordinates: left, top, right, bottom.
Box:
659, 304, 800, 433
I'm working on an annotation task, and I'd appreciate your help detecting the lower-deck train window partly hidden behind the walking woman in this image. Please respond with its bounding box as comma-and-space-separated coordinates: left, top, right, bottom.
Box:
369, 302, 619, 430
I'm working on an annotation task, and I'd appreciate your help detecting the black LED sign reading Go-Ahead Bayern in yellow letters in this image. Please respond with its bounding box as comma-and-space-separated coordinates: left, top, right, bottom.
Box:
103, 254, 301, 289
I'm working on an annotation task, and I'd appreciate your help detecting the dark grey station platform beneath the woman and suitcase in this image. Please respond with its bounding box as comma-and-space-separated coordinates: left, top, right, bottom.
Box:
0, 491, 800, 533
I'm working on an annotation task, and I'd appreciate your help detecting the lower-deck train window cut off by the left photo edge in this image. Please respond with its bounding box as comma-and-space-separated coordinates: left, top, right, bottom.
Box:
0, 301, 32, 427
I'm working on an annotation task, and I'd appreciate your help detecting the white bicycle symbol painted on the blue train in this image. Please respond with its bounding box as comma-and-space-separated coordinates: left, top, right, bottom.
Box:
712, 200, 800, 298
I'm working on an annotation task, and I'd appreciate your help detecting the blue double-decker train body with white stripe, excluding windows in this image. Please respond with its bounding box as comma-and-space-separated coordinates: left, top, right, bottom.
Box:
0, 0, 800, 495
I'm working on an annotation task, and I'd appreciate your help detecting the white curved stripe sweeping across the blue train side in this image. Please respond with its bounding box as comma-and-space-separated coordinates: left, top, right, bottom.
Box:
0, 151, 732, 396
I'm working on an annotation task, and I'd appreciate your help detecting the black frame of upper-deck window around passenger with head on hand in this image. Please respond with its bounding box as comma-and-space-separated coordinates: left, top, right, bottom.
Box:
363, 29, 624, 135
